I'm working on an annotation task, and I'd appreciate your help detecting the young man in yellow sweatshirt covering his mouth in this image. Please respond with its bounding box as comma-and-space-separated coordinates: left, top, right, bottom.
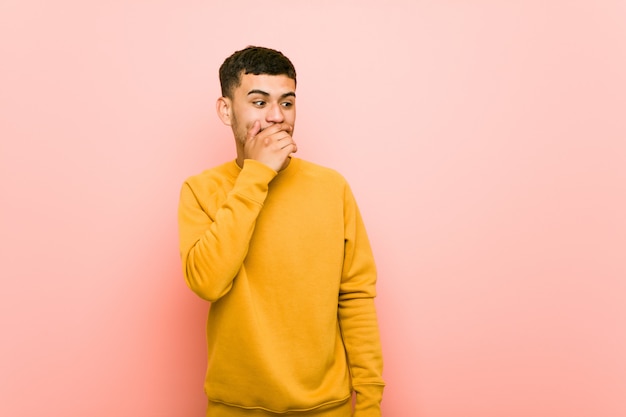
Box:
174, 47, 384, 417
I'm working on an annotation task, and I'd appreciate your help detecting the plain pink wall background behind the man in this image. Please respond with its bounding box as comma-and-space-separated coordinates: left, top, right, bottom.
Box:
0, 0, 626, 417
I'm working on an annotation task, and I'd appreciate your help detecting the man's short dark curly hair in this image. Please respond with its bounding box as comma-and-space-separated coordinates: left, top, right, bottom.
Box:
220, 46, 296, 98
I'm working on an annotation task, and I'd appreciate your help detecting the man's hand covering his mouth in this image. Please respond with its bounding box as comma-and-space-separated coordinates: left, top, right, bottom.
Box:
243, 120, 298, 171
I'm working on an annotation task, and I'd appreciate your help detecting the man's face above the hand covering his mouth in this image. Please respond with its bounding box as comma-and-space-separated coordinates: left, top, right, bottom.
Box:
227, 74, 296, 145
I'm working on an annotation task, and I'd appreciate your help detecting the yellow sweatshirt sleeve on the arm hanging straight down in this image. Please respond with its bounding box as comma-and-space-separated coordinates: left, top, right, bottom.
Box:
338, 185, 385, 417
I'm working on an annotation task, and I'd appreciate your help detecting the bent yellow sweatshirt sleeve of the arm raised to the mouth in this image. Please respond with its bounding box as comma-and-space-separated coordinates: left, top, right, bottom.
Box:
178, 160, 276, 301
